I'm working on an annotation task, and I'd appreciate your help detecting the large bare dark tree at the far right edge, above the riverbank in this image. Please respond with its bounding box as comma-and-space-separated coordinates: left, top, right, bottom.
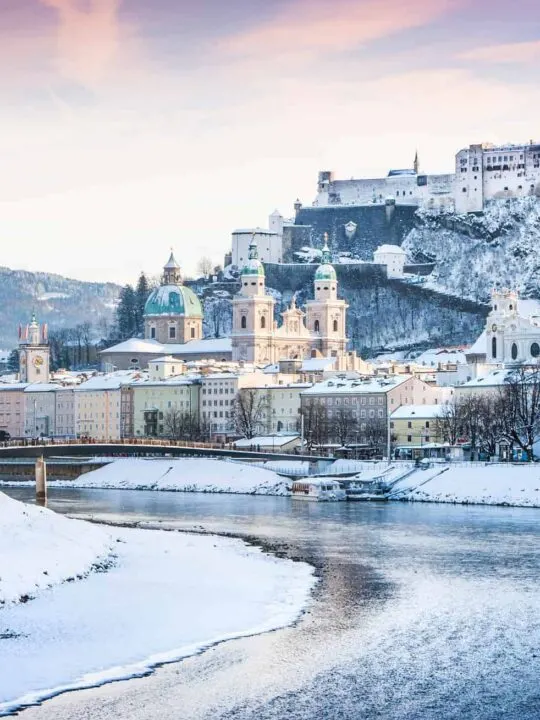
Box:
500, 365, 540, 462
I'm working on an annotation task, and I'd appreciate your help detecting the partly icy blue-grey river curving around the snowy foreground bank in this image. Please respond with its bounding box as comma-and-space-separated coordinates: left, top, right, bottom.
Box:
5, 488, 540, 720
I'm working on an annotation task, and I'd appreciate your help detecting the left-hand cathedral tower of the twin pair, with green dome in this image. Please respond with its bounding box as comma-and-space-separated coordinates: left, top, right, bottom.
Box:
232, 238, 274, 364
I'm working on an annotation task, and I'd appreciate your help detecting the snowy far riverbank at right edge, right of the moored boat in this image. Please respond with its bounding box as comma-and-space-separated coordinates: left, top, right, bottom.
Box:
392, 463, 540, 507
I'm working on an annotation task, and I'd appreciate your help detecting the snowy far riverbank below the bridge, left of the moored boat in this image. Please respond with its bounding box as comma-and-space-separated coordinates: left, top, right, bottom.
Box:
60, 458, 288, 495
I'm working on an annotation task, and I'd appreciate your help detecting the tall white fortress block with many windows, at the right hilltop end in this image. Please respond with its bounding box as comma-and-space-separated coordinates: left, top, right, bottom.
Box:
454, 142, 540, 213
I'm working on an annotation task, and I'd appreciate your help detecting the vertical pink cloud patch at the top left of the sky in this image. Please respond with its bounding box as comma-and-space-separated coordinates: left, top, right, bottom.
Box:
41, 0, 122, 87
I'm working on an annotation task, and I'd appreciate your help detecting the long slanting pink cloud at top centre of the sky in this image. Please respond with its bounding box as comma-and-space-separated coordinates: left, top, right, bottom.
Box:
224, 0, 464, 55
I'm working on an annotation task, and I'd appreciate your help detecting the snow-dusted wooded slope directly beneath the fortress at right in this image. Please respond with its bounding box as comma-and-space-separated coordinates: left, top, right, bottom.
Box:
403, 197, 540, 302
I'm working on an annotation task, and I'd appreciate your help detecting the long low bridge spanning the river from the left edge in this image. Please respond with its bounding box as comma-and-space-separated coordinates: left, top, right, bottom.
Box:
0, 439, 334, 463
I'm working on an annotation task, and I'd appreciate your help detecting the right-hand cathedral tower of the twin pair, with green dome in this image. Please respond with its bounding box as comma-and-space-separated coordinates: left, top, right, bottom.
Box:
306, 233, 349, 357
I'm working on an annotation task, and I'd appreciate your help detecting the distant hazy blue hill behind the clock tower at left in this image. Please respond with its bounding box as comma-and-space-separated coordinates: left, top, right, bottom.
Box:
0, 267, 120, 349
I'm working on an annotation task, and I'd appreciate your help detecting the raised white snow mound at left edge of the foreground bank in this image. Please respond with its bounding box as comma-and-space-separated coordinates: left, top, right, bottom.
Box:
0, 493, 114, 605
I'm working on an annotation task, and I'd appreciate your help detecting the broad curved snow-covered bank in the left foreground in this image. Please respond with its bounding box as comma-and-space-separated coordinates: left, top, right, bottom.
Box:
0, 494, 315, 715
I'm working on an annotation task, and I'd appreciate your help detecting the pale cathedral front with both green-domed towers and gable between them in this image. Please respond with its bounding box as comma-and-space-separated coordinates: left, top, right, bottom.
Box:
232, 238, 348, 364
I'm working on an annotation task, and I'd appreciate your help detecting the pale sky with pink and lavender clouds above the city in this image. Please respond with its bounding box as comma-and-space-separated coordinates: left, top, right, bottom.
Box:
0, 0, 540, 283
